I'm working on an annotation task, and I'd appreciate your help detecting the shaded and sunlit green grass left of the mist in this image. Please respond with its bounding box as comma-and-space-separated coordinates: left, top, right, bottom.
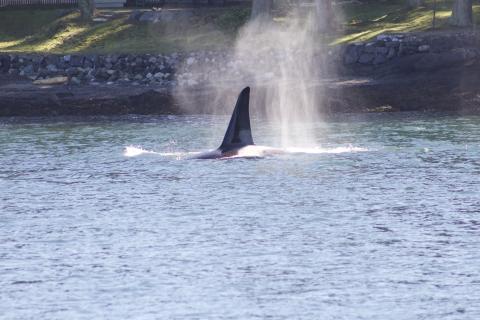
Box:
0, 7, 249, 53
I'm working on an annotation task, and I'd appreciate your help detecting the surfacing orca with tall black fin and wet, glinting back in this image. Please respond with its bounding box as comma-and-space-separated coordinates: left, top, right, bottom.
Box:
192, 87, 285, 159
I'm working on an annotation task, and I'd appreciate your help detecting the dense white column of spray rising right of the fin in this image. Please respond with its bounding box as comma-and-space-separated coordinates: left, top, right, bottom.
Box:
234, 10, 321, 147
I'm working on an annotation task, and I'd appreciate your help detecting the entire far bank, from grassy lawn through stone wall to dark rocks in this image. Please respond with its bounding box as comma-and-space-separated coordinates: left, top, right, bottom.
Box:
0, 1, 480, 116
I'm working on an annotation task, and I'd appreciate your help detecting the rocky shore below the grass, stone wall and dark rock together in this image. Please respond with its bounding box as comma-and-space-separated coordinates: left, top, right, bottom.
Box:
0, 32, 480, 116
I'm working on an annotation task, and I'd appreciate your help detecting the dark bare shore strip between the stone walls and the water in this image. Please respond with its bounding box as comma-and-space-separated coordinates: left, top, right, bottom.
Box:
0, 65, 480, 117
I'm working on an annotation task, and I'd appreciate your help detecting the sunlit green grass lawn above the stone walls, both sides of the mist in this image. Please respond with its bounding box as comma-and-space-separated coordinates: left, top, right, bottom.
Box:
0, 0, 480, 54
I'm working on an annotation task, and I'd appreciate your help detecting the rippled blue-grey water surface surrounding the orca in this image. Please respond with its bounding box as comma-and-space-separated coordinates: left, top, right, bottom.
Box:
0, 114, 480, 320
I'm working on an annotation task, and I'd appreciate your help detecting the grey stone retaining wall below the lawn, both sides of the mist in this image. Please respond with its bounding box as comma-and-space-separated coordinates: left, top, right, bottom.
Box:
0, 32, 480, 87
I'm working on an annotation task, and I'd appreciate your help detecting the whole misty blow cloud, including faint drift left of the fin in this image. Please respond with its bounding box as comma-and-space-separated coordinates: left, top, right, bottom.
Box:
177, 4, 330, 148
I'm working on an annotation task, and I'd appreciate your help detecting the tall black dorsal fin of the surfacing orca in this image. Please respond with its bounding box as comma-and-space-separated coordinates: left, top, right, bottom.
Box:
219, 87, 253, 152
